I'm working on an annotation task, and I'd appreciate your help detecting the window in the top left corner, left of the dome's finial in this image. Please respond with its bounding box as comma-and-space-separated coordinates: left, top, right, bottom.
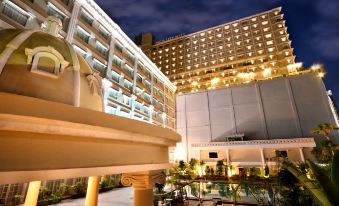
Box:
2, 1, 30, 26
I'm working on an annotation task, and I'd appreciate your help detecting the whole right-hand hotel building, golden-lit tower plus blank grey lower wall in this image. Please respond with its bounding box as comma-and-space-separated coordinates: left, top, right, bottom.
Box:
135, 8, 339, 173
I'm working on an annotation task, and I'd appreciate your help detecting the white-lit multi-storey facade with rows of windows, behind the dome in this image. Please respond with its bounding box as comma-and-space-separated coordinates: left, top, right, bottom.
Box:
0, 0, 175, 129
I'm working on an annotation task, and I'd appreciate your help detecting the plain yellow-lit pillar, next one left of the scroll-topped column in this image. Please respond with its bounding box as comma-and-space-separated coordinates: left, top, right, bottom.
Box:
85, 176, 100, 206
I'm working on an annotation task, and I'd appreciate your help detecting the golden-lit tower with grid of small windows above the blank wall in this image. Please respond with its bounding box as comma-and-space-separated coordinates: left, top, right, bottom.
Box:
137, 7, 302, 93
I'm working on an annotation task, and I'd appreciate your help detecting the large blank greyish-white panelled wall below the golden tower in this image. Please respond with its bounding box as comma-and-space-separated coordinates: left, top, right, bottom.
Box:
176, 74, 339, 160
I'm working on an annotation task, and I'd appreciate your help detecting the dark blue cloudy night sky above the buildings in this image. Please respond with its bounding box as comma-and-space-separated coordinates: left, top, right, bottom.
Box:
96, 0, 339, 104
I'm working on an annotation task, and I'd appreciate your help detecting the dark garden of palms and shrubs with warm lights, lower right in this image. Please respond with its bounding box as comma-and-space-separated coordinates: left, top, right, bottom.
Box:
154, 124, 339, 206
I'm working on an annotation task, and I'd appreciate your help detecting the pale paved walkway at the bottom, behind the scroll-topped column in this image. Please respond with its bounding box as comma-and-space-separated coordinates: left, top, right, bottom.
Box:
55, 187, 133, 206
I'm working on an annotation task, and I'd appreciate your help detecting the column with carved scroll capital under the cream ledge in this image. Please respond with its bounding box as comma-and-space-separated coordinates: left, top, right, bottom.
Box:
121, 171, 166, 206
